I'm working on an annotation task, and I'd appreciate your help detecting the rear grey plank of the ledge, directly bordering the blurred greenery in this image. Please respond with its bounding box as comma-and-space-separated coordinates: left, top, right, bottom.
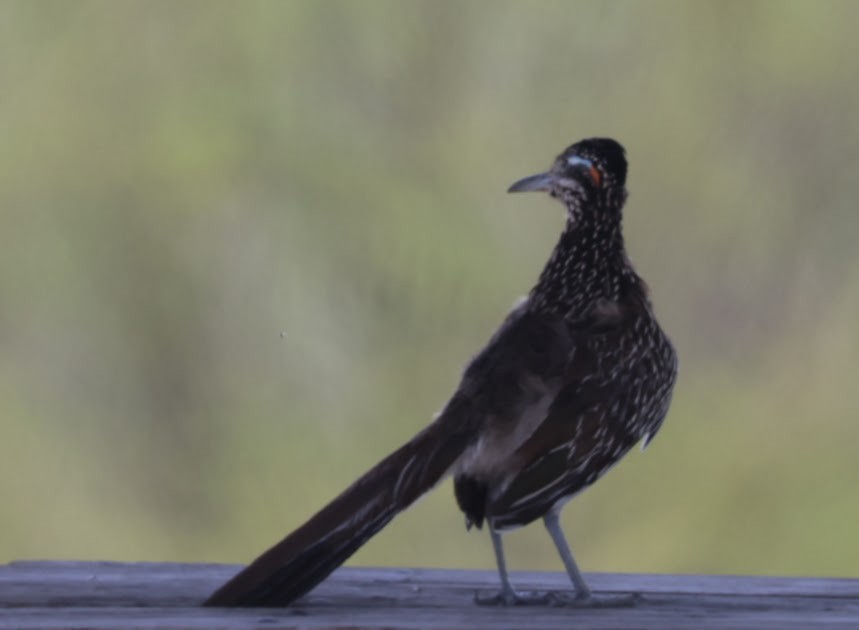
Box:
6, 561, 859, 606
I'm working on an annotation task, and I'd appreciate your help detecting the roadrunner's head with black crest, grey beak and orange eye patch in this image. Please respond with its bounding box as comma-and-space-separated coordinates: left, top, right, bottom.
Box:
508, 138, 626, 221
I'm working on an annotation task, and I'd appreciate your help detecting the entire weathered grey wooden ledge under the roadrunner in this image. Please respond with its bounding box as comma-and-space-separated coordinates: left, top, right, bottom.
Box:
0, 562, 859, 630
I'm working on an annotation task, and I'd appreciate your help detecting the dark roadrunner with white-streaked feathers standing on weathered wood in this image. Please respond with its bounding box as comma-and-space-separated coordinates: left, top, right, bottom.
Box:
203, 138, 677, 607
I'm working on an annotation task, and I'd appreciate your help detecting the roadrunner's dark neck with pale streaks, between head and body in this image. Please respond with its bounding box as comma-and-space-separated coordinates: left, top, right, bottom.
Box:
529, 216, 646, 320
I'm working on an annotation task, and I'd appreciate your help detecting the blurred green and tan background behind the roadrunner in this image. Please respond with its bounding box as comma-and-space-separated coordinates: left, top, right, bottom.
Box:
0, 0, 859, 576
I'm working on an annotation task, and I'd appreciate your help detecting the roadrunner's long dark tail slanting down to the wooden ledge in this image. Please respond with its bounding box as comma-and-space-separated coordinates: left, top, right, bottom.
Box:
203, 400, 476, 606
